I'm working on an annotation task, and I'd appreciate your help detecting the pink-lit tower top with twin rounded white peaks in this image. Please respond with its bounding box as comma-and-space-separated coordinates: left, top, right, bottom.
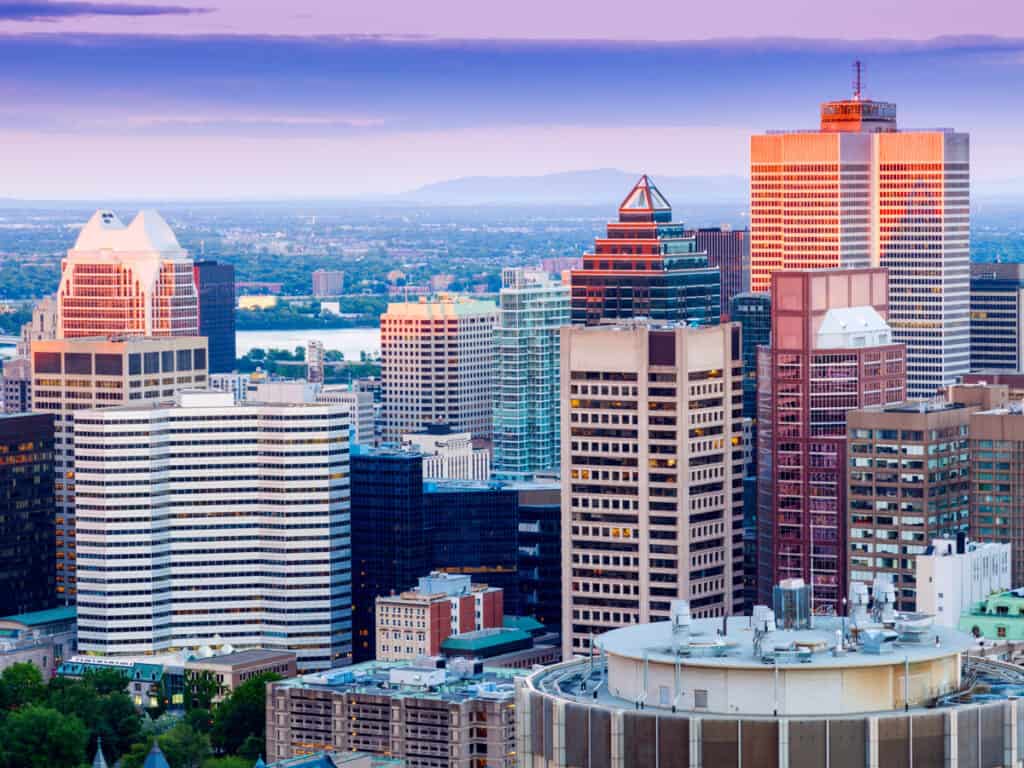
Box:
56, 210, 200, 339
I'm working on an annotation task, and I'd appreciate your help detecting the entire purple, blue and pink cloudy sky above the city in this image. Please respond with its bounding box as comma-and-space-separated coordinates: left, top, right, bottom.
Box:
0, 0, 1024, 202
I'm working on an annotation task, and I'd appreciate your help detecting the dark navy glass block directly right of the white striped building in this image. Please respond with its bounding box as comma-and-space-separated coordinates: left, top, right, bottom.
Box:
351, 445, 421, 664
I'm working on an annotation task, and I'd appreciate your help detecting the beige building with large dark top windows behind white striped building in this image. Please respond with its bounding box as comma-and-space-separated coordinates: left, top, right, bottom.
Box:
32, 336, 207, 601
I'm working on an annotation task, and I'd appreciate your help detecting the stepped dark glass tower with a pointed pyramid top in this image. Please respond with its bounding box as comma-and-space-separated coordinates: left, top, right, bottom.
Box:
571, 176, 722, 326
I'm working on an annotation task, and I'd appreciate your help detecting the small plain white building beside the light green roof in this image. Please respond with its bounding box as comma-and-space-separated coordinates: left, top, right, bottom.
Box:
916, 535, 1012, 630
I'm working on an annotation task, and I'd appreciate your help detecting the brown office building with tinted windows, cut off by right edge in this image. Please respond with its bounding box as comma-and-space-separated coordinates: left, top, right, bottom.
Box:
970, 402, 1024, 585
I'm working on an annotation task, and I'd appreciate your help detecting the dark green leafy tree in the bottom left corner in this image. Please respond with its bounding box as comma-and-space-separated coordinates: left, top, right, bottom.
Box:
0, 705, 89, 768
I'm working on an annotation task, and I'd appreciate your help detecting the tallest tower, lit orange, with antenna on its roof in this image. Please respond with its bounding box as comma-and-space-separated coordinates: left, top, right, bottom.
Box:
751, 67, 970, 397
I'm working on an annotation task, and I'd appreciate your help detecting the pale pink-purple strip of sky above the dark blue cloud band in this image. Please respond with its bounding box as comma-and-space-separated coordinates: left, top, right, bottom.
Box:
0, 0, 1024, 41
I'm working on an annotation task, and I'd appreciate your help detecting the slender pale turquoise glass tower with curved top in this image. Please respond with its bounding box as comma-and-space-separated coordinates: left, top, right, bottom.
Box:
494, 269, 569, 477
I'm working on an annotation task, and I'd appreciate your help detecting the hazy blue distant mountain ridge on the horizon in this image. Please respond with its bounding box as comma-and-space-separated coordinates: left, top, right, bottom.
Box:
400, 168, 749, 207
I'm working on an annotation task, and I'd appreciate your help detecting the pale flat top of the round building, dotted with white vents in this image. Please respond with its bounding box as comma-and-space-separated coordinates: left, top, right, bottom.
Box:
595, 616, 975, 670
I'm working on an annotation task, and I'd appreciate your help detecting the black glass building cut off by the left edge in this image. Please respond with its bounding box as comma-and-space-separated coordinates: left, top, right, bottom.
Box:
0, 414, 56, 618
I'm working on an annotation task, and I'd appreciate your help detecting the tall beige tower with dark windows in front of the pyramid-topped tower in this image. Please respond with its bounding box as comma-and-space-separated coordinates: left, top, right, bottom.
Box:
561, 323, 743, 658
